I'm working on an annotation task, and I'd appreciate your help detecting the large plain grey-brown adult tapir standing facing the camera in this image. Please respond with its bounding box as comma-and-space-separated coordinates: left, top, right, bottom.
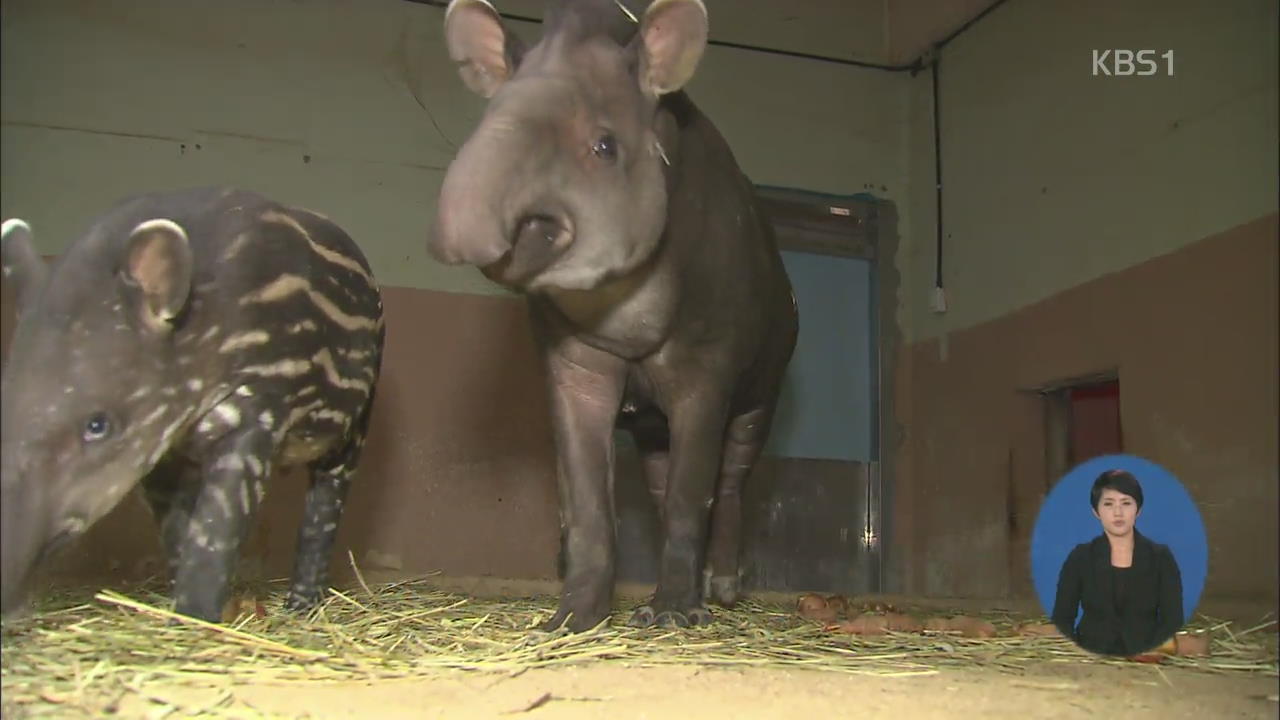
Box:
429, 0, 797, 630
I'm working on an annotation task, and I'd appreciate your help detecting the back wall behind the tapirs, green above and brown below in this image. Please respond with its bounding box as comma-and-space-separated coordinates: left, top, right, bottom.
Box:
0, 0, 906, 594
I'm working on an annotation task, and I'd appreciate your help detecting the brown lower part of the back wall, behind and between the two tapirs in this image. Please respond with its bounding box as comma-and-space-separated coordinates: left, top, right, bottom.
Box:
0, 280, 559, 589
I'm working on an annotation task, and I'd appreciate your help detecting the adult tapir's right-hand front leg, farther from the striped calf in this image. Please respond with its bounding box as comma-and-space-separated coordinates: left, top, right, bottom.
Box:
628, 383, 728, 626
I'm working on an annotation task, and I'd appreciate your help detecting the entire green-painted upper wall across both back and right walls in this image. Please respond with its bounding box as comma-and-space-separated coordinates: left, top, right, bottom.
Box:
0, 0, 1277, 340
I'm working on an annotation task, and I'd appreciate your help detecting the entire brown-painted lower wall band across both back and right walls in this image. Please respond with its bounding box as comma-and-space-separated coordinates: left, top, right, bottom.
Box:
0, 215, 1277, 605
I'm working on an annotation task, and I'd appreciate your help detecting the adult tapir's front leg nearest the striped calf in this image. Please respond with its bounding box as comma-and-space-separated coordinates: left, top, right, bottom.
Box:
544, 340, 626, 633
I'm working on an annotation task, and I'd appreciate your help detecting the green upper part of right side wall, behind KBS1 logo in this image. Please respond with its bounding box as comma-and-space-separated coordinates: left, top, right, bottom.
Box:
900, 0, 1277, 340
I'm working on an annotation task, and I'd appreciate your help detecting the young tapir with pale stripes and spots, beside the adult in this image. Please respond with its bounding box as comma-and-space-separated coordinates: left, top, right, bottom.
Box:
0, 188, 384, 621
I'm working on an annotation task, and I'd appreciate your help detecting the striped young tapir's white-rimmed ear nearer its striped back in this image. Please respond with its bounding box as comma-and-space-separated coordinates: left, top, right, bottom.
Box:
122, 218, 193, 329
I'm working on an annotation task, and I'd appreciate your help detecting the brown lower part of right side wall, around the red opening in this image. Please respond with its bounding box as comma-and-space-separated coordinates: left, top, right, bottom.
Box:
893, 215, 1280, 605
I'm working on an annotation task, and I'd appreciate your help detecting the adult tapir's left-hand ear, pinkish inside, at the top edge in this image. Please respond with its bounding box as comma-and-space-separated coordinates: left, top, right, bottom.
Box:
444, 0, 524, 97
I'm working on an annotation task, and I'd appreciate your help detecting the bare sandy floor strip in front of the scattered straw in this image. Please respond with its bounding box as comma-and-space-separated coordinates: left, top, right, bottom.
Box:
104, 662, 1280, 720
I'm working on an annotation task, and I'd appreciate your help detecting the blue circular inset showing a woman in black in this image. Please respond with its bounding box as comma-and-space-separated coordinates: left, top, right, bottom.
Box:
1030, 455, 1208, 655
